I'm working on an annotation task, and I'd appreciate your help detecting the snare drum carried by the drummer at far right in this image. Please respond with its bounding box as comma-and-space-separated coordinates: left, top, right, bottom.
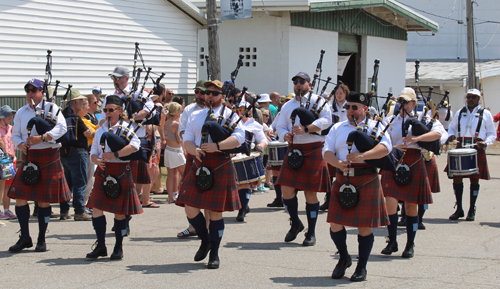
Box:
448, 148, 479, 178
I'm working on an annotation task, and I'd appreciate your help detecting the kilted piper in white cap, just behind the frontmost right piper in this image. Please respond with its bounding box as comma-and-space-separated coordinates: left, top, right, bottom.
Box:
382, 87, 445, 258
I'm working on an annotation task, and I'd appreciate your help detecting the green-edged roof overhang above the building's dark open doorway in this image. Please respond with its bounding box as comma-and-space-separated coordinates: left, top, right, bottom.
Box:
311, 0, 439, 32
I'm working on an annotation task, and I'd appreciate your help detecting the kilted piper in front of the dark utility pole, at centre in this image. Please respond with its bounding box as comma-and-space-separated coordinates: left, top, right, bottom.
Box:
176, 80, 245, 269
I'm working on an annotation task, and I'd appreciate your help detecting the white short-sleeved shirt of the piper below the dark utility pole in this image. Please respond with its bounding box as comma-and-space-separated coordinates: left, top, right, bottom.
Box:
183, 105, 245, 147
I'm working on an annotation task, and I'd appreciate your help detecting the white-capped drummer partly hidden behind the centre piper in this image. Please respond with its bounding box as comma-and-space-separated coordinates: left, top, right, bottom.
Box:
236, 101, 268, 222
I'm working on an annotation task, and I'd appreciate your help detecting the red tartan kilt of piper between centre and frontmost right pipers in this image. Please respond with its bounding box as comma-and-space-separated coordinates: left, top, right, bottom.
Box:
277, 142, 332, 192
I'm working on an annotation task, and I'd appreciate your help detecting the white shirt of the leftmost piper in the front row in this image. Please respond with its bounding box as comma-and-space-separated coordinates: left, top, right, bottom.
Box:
11, 101, 67, 150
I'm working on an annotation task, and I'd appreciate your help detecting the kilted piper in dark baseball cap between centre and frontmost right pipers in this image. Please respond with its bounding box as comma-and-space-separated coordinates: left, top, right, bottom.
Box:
275, 72, 332, 246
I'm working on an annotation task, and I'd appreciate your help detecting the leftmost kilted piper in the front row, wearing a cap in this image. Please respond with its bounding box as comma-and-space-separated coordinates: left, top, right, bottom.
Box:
8, 78, 71, 253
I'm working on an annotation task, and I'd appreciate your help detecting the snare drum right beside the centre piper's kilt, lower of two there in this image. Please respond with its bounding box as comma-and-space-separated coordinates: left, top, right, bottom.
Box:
231, 152, 265, 185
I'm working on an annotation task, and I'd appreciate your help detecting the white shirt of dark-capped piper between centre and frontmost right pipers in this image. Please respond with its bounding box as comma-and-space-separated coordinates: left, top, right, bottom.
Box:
276, 93, 332, 144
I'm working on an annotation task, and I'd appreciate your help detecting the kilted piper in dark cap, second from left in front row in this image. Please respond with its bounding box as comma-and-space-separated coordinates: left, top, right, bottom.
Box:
87, 95, 143, 260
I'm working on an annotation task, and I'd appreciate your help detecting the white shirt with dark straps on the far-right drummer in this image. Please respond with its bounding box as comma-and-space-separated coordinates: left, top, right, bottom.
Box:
448, 105, 497, 147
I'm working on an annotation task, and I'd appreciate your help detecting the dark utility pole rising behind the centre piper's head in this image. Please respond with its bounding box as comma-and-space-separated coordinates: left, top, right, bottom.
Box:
206, 0, 221, 80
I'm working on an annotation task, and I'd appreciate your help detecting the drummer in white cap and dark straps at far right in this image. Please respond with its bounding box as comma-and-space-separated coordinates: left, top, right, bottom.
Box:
448, 88, 496, 221
